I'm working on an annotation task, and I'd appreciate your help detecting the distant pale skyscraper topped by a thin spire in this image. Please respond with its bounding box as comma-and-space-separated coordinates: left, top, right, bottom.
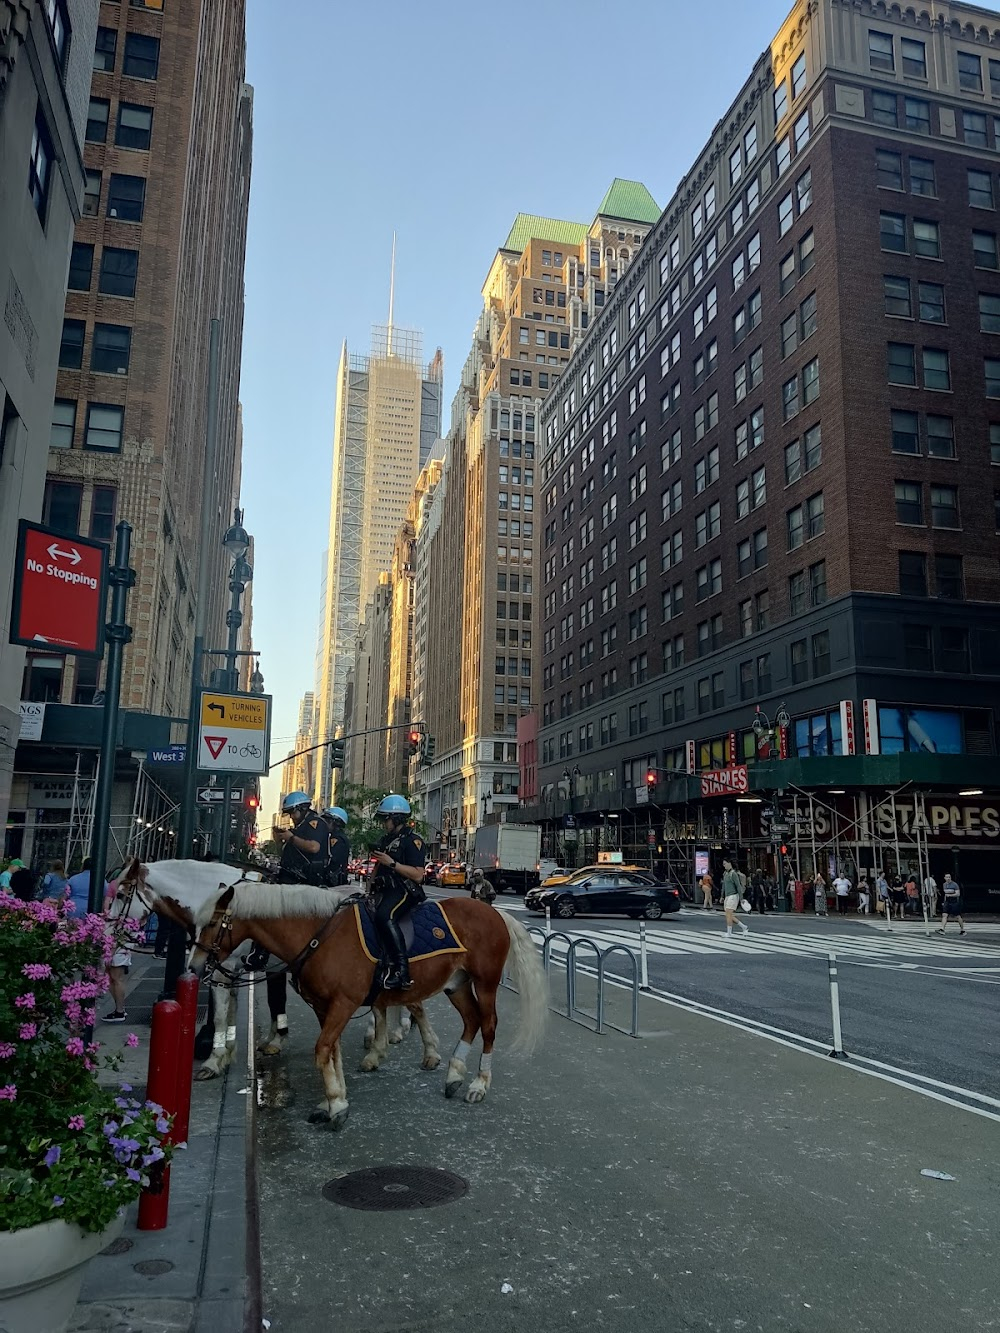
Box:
316, 311, 444, 805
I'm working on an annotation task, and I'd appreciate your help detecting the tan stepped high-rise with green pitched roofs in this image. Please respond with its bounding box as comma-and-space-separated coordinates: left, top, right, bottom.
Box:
412, 180, 660, 842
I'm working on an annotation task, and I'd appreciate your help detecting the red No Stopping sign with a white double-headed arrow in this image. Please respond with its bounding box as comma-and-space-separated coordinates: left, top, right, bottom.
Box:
11, 519, 108, 657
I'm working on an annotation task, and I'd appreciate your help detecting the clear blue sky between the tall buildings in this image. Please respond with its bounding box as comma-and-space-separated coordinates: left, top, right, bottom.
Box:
234, 0, 922, 817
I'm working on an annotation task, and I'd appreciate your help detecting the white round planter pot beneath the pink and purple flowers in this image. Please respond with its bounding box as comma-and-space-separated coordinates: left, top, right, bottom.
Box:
0, 1213, 125, 1333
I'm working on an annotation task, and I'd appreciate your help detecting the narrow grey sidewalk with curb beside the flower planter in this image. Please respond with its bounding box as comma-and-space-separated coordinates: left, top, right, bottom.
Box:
69, 954, 253, 1333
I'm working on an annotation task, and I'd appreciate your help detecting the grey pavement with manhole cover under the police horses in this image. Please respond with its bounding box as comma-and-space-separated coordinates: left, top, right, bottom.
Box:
257, 973, 1000, 1333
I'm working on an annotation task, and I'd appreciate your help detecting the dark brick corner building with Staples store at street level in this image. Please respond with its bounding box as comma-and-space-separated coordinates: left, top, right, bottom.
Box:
533, 0, 1000, 902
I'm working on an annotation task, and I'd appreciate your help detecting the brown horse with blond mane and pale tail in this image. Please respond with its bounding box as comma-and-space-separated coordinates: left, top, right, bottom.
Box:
189, 882, 548, 1129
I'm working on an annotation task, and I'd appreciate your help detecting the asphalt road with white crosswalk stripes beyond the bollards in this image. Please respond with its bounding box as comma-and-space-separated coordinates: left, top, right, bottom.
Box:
497, 897, 1000, 1097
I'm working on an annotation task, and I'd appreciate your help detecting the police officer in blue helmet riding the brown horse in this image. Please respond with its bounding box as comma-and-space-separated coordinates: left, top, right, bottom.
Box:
371, 796, 427, 990
